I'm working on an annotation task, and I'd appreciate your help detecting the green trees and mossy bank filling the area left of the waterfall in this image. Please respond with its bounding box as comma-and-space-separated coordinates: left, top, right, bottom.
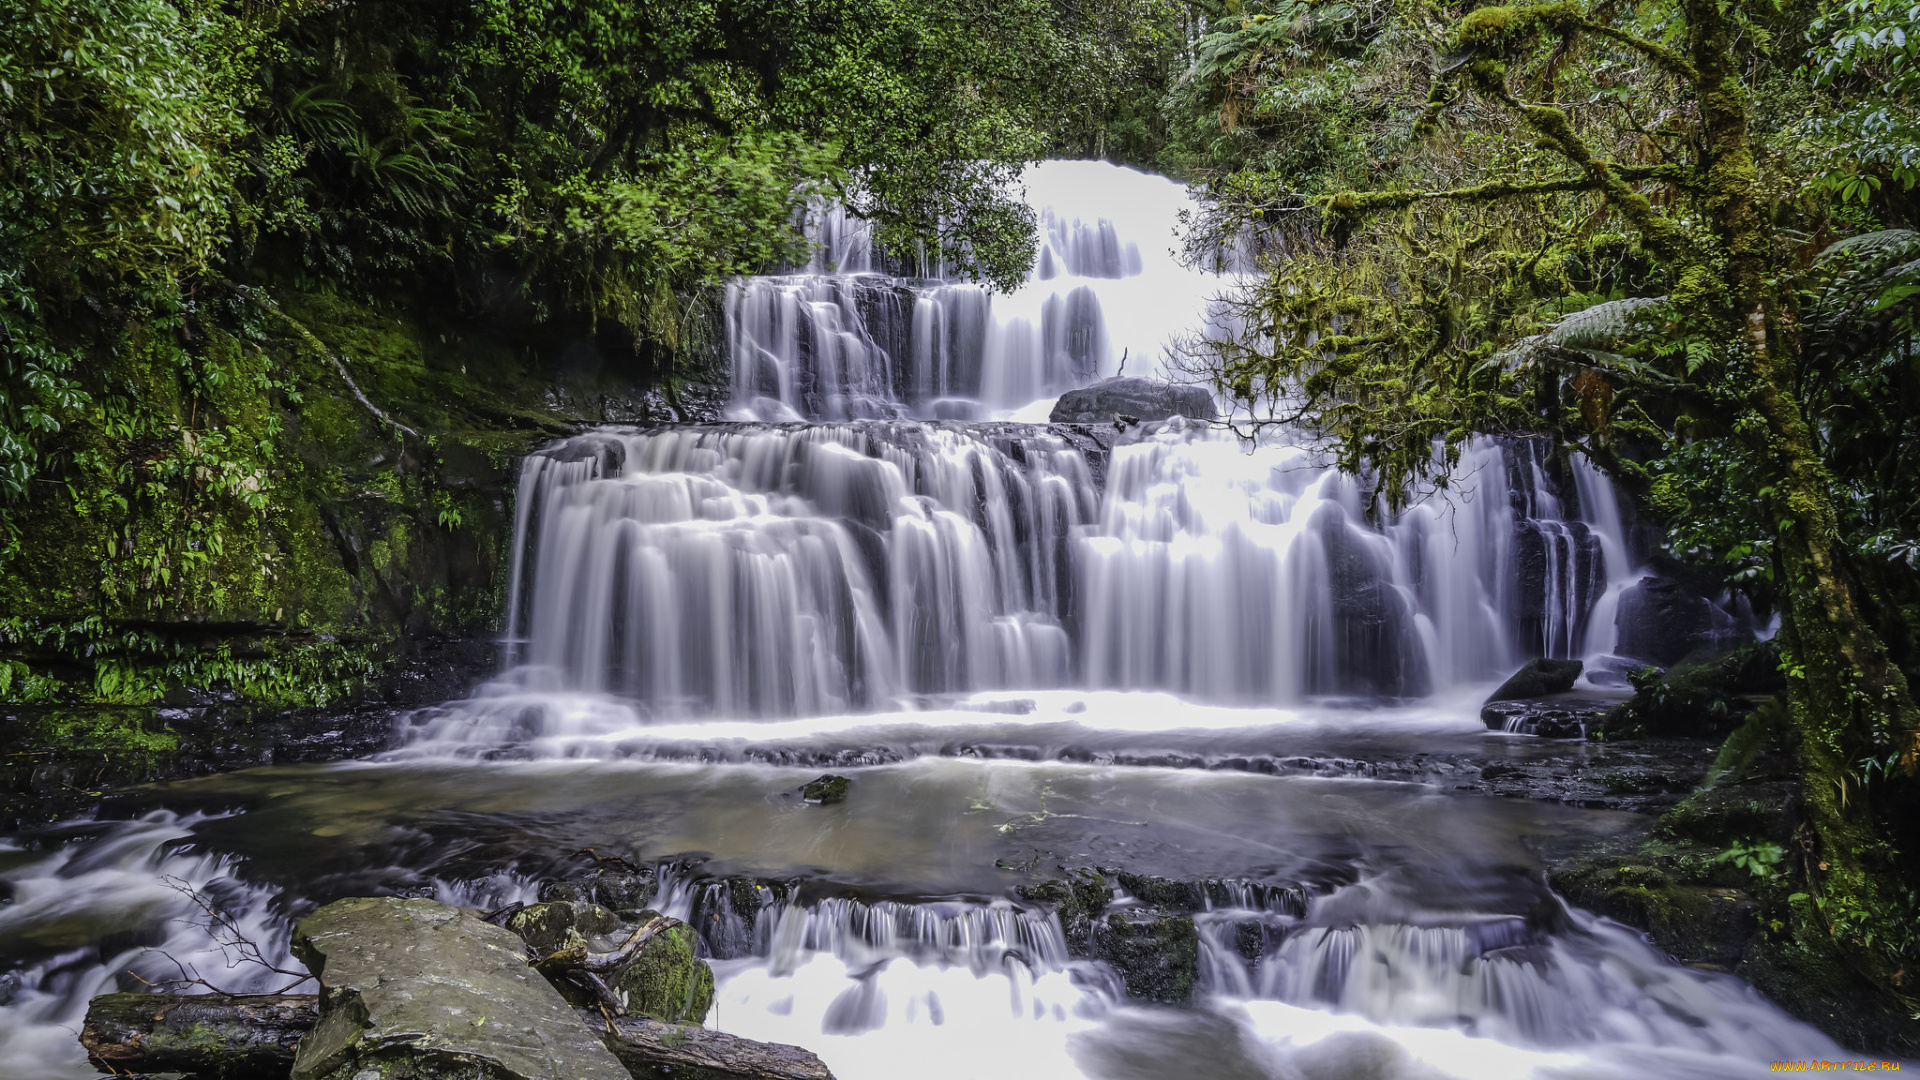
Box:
0, 0, 1146, 703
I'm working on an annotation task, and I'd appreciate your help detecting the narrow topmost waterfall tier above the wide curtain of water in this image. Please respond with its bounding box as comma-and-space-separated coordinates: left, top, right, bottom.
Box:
726, 161, 1223, 421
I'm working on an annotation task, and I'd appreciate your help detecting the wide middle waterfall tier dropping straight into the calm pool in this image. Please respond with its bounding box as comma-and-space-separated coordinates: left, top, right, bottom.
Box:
509, 421, 1611, 717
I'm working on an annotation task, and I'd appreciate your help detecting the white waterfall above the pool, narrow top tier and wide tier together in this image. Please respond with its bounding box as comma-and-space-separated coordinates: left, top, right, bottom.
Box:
413, 161, 1632, 734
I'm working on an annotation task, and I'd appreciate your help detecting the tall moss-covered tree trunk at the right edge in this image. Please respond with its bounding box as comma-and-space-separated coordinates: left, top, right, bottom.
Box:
1686, 0, 1920, 995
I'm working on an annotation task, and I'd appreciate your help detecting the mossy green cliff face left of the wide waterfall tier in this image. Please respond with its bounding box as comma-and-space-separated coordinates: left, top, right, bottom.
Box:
0, 286, 718, 714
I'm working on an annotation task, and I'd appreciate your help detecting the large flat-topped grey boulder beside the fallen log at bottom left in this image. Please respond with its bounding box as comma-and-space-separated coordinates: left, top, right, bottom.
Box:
292, 897, 628, 1080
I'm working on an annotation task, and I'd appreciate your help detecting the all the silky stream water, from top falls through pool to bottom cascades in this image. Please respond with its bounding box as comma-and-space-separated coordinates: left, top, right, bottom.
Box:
0, 161, 1841, 1080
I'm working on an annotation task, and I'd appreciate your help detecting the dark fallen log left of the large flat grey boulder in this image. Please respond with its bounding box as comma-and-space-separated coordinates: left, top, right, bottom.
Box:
81, 994, 321, 1080
